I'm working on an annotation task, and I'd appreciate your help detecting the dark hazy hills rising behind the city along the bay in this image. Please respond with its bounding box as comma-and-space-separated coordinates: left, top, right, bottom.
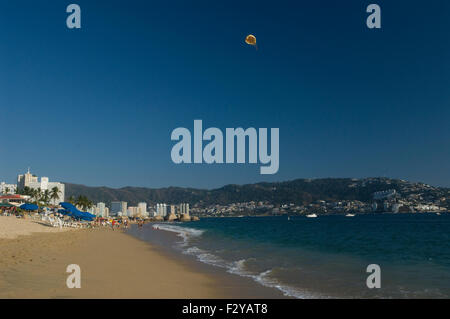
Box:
64, 178, 449, 206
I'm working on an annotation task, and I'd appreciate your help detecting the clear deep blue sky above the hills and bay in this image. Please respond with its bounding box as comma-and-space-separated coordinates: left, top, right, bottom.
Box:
0, 0, 450, 188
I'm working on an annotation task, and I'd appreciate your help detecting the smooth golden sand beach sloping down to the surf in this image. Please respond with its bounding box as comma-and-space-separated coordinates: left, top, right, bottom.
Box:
0, 221, 282, 299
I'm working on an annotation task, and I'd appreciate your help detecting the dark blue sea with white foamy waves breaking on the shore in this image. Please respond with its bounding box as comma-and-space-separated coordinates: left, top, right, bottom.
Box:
140, 214, 450, 298
